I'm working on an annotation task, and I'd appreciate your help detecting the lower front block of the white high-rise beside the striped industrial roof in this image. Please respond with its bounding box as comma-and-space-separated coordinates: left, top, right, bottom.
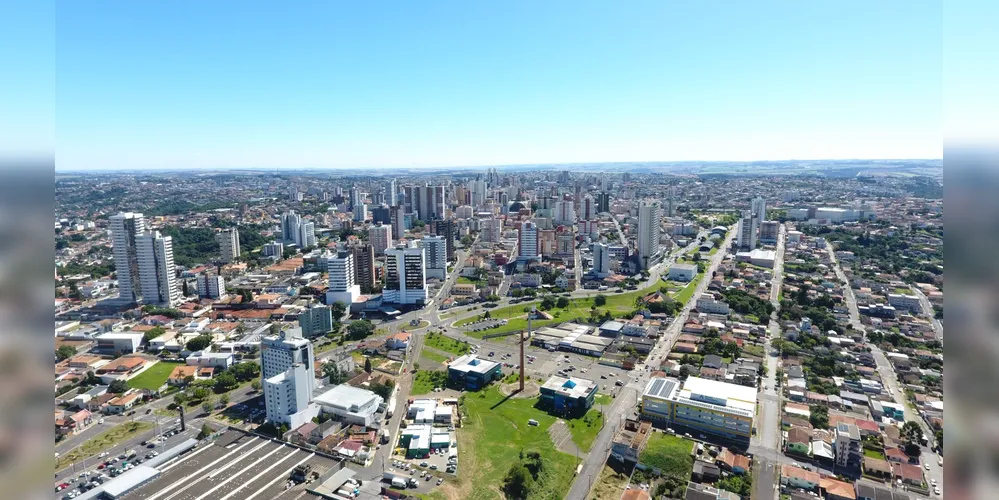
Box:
263, 363, 319, 429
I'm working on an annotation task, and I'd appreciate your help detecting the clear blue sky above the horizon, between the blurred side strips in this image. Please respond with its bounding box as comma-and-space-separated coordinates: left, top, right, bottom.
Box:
55, 0, 943, 169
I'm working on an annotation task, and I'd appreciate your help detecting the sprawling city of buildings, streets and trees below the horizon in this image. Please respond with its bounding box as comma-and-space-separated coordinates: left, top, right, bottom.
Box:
55, 160, 943, 500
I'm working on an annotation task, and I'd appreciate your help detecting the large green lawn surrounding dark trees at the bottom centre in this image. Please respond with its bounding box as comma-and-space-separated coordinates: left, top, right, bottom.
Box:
449, 387, 576, 499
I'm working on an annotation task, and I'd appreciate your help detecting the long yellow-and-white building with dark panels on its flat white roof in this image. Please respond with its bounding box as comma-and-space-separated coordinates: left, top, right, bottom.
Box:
641, 377, 756, 441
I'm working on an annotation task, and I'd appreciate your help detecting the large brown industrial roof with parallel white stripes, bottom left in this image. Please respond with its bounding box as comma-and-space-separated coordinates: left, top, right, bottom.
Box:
123, 431, 336, 500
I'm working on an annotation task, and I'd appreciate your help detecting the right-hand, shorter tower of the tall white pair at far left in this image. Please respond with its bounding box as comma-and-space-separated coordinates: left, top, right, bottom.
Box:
135, 231, 180, 306
